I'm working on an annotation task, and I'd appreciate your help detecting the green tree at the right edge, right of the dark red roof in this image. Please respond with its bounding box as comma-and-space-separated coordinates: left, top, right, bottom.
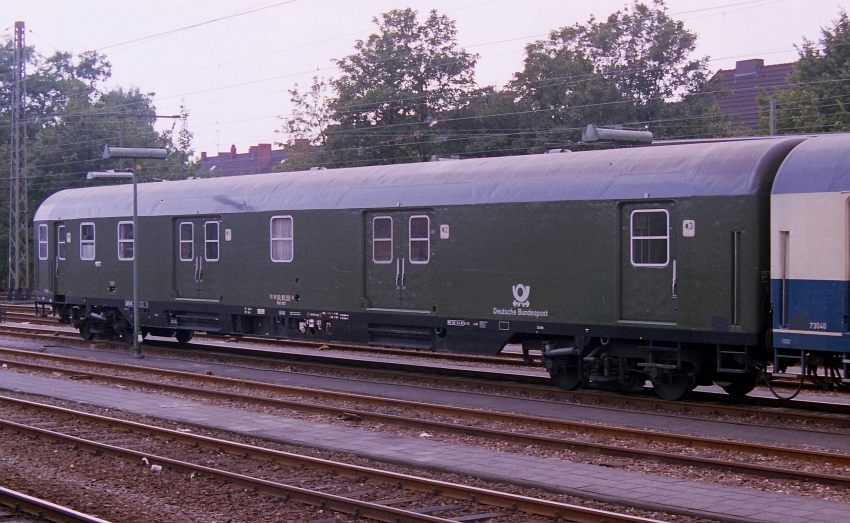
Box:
759, 10, 850, 134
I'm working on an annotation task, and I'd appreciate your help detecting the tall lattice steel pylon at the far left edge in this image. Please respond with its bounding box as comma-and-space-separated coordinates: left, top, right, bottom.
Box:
9, 22, 30, 300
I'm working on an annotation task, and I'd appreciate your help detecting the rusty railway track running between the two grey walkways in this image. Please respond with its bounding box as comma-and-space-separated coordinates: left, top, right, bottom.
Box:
0, 349, 850, 487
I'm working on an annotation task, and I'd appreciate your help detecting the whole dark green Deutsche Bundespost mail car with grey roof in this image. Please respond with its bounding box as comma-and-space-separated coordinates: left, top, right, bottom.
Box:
34, 138, 802, 398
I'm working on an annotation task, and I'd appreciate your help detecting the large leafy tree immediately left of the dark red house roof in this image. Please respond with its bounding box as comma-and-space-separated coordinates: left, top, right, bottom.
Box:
510, 0, 728, 143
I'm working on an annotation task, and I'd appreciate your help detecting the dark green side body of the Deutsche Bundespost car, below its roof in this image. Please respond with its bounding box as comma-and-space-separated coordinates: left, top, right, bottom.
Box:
37, 195, 770, 352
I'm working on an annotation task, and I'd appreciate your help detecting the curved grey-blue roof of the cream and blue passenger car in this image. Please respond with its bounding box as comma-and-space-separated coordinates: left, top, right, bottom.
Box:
773, 134, 850, 194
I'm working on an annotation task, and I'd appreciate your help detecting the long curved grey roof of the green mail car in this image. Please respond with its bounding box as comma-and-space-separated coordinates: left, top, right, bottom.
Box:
34, 138, 803, 221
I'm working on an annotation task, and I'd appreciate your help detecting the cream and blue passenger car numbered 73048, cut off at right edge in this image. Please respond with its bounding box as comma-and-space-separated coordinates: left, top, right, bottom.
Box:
771, 134, 850, 382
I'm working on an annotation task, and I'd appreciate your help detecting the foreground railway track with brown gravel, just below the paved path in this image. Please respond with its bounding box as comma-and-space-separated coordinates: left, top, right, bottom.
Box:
0, 397, 654, 523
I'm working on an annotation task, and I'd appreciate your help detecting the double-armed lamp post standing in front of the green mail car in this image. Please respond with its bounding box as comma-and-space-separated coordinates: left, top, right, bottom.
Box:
86, 145, 168, 359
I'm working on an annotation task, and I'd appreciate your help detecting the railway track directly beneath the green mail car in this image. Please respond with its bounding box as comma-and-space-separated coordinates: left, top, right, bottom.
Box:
0, 325, 850, 428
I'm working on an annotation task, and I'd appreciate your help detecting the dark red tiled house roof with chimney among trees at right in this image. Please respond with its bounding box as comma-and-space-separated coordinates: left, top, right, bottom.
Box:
715, 58, 794, 131
